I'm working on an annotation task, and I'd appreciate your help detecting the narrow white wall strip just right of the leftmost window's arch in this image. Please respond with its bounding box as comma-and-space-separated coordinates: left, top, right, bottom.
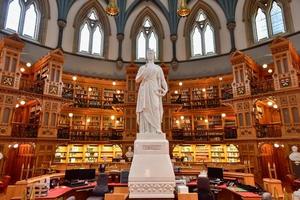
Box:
45, 0, 58, 48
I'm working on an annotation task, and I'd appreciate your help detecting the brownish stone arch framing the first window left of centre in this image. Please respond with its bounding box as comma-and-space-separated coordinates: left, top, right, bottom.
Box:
73, 0, 111, 58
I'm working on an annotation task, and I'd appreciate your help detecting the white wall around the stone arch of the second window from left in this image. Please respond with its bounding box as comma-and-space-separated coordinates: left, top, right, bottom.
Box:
62, 0, 118, 59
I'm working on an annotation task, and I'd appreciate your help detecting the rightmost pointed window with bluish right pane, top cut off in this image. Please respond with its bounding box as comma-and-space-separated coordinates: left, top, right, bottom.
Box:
253, 0, 286, 42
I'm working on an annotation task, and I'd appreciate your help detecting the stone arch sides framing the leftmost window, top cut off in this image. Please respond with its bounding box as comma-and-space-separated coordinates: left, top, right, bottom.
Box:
0, 0, 50, 44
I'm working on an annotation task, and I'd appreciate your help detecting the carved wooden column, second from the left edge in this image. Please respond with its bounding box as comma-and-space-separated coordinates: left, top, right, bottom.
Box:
32, 49, 64, 137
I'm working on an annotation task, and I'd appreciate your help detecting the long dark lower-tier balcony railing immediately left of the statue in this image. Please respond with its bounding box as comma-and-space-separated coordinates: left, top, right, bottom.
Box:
57, 127, 124, 141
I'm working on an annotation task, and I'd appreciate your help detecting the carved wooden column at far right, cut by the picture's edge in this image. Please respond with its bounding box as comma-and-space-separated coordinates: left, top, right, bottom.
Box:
270, 38, 300, 137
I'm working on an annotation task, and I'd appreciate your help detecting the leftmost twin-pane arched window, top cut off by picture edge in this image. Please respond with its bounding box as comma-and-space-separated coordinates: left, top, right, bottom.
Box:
4, 0, 41, 40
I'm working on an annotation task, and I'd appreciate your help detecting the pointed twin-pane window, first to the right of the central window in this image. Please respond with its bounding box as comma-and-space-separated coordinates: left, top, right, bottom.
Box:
190, 10, 216, 57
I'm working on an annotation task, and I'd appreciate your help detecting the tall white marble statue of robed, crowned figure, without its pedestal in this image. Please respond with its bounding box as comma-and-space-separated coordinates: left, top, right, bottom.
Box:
135, 50, 168, 133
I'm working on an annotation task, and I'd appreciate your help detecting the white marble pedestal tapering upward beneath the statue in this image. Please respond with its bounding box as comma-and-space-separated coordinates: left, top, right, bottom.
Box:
128, 133, 175, 199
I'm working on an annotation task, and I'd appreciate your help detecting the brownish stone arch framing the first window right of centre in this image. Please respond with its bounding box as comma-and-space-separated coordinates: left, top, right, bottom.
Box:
183, 1, 221, 58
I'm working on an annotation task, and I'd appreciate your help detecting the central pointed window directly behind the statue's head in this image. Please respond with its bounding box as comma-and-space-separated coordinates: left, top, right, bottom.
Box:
136, 18, 159, 59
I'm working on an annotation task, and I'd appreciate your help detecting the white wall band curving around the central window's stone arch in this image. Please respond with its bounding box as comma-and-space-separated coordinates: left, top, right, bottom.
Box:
122, 1, 172, 62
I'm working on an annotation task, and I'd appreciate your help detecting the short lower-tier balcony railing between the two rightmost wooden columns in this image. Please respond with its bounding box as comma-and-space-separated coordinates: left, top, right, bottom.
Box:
255, 124, 282, 138
